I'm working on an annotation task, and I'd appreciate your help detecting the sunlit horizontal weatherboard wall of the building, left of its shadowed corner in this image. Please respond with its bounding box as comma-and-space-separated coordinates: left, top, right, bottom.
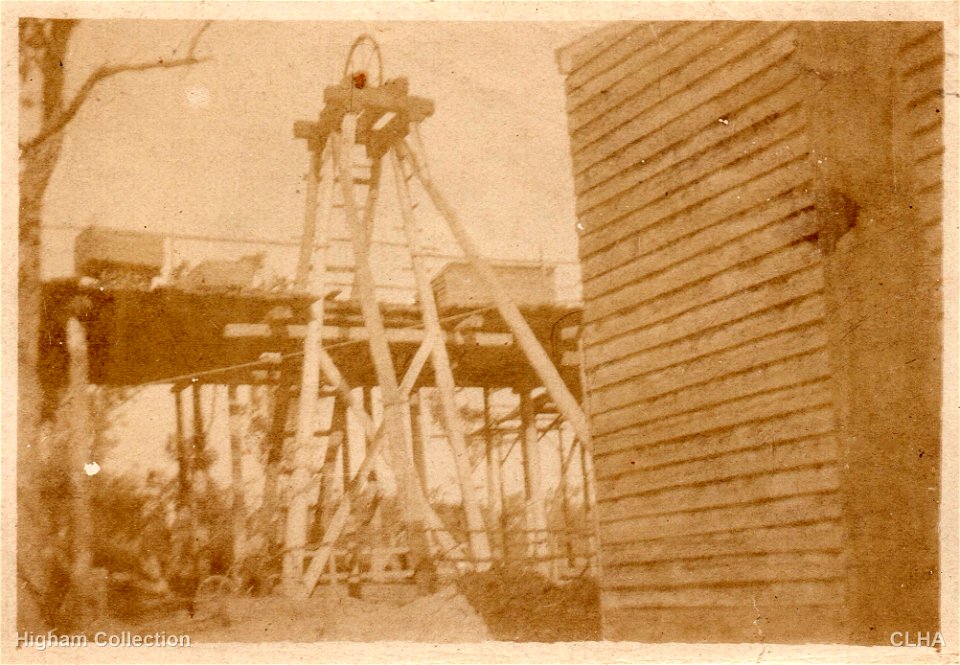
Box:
567, 22, 844, 641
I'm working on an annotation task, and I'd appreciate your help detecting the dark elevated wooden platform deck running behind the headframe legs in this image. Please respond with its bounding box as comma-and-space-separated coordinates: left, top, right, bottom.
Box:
40, 280, 581, 395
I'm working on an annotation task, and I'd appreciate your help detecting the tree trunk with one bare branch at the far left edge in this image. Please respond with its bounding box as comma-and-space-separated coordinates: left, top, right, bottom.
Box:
17, 18, 208, 633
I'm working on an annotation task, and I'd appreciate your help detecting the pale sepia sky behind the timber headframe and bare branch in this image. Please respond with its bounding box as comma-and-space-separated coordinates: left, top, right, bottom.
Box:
43, 21, 590, 498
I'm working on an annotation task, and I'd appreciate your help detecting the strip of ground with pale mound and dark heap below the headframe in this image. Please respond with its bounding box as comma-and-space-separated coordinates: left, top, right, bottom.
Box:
97, 571, 600, 644
